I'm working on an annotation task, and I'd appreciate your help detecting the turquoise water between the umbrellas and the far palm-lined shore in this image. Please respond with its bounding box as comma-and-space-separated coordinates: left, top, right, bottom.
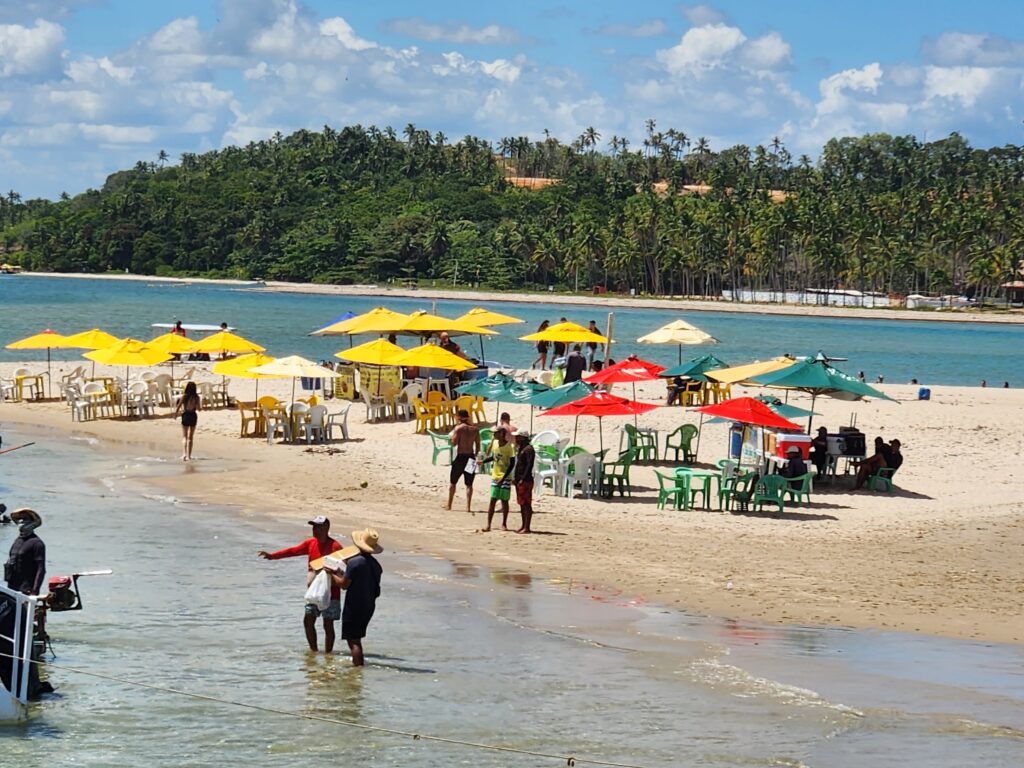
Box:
0, 275, 1024, 387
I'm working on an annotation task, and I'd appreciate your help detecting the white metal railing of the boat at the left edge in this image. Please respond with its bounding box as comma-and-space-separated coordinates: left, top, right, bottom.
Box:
0, 585, 39, 723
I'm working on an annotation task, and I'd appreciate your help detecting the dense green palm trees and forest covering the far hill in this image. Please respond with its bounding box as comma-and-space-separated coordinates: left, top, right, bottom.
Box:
0, 121, 1024, 298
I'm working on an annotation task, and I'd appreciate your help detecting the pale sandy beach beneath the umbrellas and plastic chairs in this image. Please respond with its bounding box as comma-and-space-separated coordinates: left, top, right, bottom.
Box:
0, 362, 1024, 643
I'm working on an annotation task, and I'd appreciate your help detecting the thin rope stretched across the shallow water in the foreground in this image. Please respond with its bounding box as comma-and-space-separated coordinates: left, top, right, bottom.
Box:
0, 652, 644, 768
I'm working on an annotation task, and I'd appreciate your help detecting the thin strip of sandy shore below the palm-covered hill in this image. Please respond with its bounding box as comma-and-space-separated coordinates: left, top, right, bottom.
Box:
19, 272, 1024, 326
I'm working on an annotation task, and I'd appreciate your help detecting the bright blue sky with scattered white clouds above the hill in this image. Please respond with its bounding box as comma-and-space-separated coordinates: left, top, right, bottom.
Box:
0, 0, 1024, 199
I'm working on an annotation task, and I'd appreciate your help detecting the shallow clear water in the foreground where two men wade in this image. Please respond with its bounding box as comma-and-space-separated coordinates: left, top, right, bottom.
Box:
0, 428, 1024, 768
